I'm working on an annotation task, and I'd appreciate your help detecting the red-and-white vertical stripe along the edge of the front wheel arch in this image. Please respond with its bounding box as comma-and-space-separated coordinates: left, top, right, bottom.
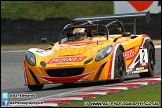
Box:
107, 43, 120, 80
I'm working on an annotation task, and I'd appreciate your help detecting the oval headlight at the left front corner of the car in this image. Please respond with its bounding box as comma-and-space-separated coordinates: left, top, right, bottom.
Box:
25, 51, 36, 66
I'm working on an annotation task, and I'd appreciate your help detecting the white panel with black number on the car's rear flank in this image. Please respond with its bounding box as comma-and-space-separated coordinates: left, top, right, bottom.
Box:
140, 48, 148, 66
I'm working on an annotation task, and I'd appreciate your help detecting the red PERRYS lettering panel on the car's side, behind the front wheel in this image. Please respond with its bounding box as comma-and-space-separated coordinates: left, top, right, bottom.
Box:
123, 48, 135, 60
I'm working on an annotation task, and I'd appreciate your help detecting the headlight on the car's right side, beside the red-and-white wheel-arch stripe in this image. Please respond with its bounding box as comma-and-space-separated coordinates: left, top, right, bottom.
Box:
95, 45, 113, 61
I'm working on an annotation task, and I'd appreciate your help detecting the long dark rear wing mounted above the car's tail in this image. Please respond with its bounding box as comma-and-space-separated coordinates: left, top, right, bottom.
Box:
72, 11, 150, 23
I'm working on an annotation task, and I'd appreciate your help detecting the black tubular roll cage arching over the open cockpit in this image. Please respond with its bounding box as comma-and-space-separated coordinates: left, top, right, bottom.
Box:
59, 20, 125, 43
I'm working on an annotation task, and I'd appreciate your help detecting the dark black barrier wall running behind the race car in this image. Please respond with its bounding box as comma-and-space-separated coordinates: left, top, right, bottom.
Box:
1, 13, 161, 45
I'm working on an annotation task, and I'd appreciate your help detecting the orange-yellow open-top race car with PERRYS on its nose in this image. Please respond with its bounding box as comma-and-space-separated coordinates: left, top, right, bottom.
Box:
24, 12, 155, 91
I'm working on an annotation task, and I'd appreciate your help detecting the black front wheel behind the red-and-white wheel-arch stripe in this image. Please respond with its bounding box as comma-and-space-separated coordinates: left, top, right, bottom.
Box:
114, 48, 126, 83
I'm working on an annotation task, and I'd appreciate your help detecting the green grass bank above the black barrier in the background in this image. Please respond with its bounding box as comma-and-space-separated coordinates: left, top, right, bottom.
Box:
1, 1, 114, 20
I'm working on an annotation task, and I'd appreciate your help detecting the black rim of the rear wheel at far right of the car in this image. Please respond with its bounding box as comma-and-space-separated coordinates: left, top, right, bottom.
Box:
149, 50, 155, 71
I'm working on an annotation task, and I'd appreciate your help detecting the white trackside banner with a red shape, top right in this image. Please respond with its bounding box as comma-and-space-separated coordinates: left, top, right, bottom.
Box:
114, 1, 161, 14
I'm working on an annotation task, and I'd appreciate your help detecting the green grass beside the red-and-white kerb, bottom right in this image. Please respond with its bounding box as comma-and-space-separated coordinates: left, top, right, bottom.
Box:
59, 82, 161, 107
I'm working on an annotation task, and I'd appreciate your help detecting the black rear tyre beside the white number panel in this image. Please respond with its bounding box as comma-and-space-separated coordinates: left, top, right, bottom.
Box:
139, 44, 155, 78
